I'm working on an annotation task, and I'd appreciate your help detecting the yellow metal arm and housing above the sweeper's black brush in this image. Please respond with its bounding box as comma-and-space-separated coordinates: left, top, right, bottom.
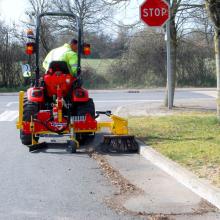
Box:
98, 115, 128, 135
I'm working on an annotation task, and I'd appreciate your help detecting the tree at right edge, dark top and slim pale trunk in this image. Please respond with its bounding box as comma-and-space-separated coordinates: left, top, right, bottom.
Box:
205, 0, 220, 119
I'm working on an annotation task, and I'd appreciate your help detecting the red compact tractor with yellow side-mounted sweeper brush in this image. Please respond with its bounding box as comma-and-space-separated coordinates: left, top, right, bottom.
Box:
17, 12, 137, 153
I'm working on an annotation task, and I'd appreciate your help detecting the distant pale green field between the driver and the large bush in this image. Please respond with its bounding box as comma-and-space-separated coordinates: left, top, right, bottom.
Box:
82, 59, 114, 75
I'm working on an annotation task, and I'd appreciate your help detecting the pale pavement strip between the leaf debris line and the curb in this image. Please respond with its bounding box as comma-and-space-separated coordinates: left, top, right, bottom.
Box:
104, 154, 220, 220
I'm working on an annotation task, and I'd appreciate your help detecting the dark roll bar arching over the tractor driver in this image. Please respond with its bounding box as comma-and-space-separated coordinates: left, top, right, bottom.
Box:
35, 12, 82, 87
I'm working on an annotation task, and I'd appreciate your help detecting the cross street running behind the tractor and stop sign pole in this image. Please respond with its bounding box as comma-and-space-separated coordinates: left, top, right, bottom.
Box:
0, 89, 216, 117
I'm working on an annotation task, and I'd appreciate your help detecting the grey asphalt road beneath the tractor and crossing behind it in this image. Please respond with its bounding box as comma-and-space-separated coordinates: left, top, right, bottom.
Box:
0, 90, 218, 220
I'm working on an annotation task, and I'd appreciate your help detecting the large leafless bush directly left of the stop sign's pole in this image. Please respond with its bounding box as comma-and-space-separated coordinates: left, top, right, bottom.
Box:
108, 29, 166, 88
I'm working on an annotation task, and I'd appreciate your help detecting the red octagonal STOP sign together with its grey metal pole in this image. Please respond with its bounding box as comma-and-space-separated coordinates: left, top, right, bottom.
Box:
140, 0, 172, 109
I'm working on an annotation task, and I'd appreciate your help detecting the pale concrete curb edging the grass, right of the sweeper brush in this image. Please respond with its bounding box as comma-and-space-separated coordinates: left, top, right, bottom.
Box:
139, 142, 220, 209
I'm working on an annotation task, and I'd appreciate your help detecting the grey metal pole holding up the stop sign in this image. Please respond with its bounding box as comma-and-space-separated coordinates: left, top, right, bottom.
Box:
166, 0, 173, 109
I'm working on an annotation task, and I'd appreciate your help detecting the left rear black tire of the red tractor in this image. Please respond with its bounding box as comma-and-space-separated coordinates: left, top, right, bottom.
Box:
20, 100, 39, 145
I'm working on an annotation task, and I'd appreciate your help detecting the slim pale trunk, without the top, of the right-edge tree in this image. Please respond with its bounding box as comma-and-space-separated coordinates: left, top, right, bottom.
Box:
215, 30, 220, 120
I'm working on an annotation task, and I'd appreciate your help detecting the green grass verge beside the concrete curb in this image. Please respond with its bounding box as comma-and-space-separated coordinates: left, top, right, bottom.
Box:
129, 113, 220, 187
